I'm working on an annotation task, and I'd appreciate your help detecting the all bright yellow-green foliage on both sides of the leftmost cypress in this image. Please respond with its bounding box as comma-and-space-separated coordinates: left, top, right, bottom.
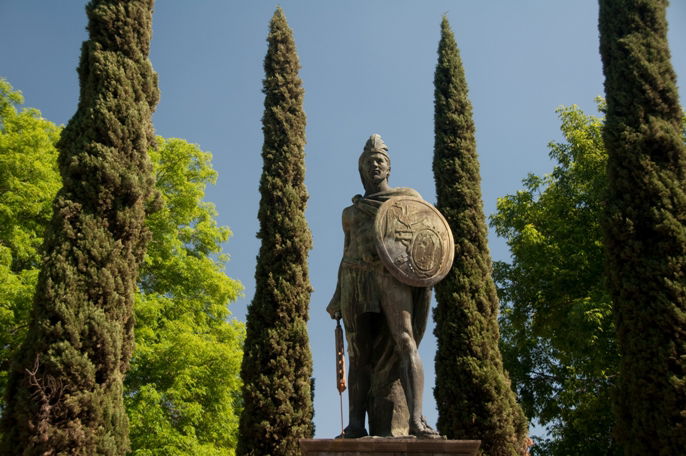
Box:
0, 81, 244, 456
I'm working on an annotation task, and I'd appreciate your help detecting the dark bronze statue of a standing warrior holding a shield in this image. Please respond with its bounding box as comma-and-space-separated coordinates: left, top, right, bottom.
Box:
327, 134, 454, 438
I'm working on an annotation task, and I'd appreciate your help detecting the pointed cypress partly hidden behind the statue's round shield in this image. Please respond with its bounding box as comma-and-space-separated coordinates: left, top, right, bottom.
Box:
433, 17, 527, 456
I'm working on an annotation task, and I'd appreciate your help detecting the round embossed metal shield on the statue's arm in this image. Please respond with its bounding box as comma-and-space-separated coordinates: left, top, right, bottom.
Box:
374, 196, 455, 287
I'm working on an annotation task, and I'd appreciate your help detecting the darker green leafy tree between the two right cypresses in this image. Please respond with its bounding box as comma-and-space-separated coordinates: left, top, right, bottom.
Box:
491, 106, 620, 455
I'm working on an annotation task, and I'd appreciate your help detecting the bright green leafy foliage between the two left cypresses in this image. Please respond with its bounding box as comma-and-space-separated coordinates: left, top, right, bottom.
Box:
125, 138, 244, 456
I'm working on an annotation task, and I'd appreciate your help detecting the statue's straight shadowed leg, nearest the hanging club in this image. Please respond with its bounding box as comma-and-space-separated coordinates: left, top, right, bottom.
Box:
343, 314, 372, 438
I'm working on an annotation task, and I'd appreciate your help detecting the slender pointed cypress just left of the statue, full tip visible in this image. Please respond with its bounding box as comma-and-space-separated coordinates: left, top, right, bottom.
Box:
237, 8, 313, 456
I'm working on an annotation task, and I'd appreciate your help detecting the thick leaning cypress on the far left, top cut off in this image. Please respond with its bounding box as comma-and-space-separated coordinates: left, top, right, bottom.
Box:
0, 0, 158, 456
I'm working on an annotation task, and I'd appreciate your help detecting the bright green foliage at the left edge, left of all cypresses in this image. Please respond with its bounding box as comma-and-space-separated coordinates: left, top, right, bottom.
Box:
0, 79, 62, 409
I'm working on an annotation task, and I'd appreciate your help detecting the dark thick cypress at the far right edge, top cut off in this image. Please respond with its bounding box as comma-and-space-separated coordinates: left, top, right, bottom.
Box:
599, 0, 686, 455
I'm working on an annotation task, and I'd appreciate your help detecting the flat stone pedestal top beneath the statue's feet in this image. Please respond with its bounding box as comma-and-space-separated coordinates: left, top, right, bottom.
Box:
300, 437, 481, 456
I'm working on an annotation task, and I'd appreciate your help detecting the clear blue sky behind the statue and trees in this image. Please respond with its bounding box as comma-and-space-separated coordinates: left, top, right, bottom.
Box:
0, 0, 686, 437
